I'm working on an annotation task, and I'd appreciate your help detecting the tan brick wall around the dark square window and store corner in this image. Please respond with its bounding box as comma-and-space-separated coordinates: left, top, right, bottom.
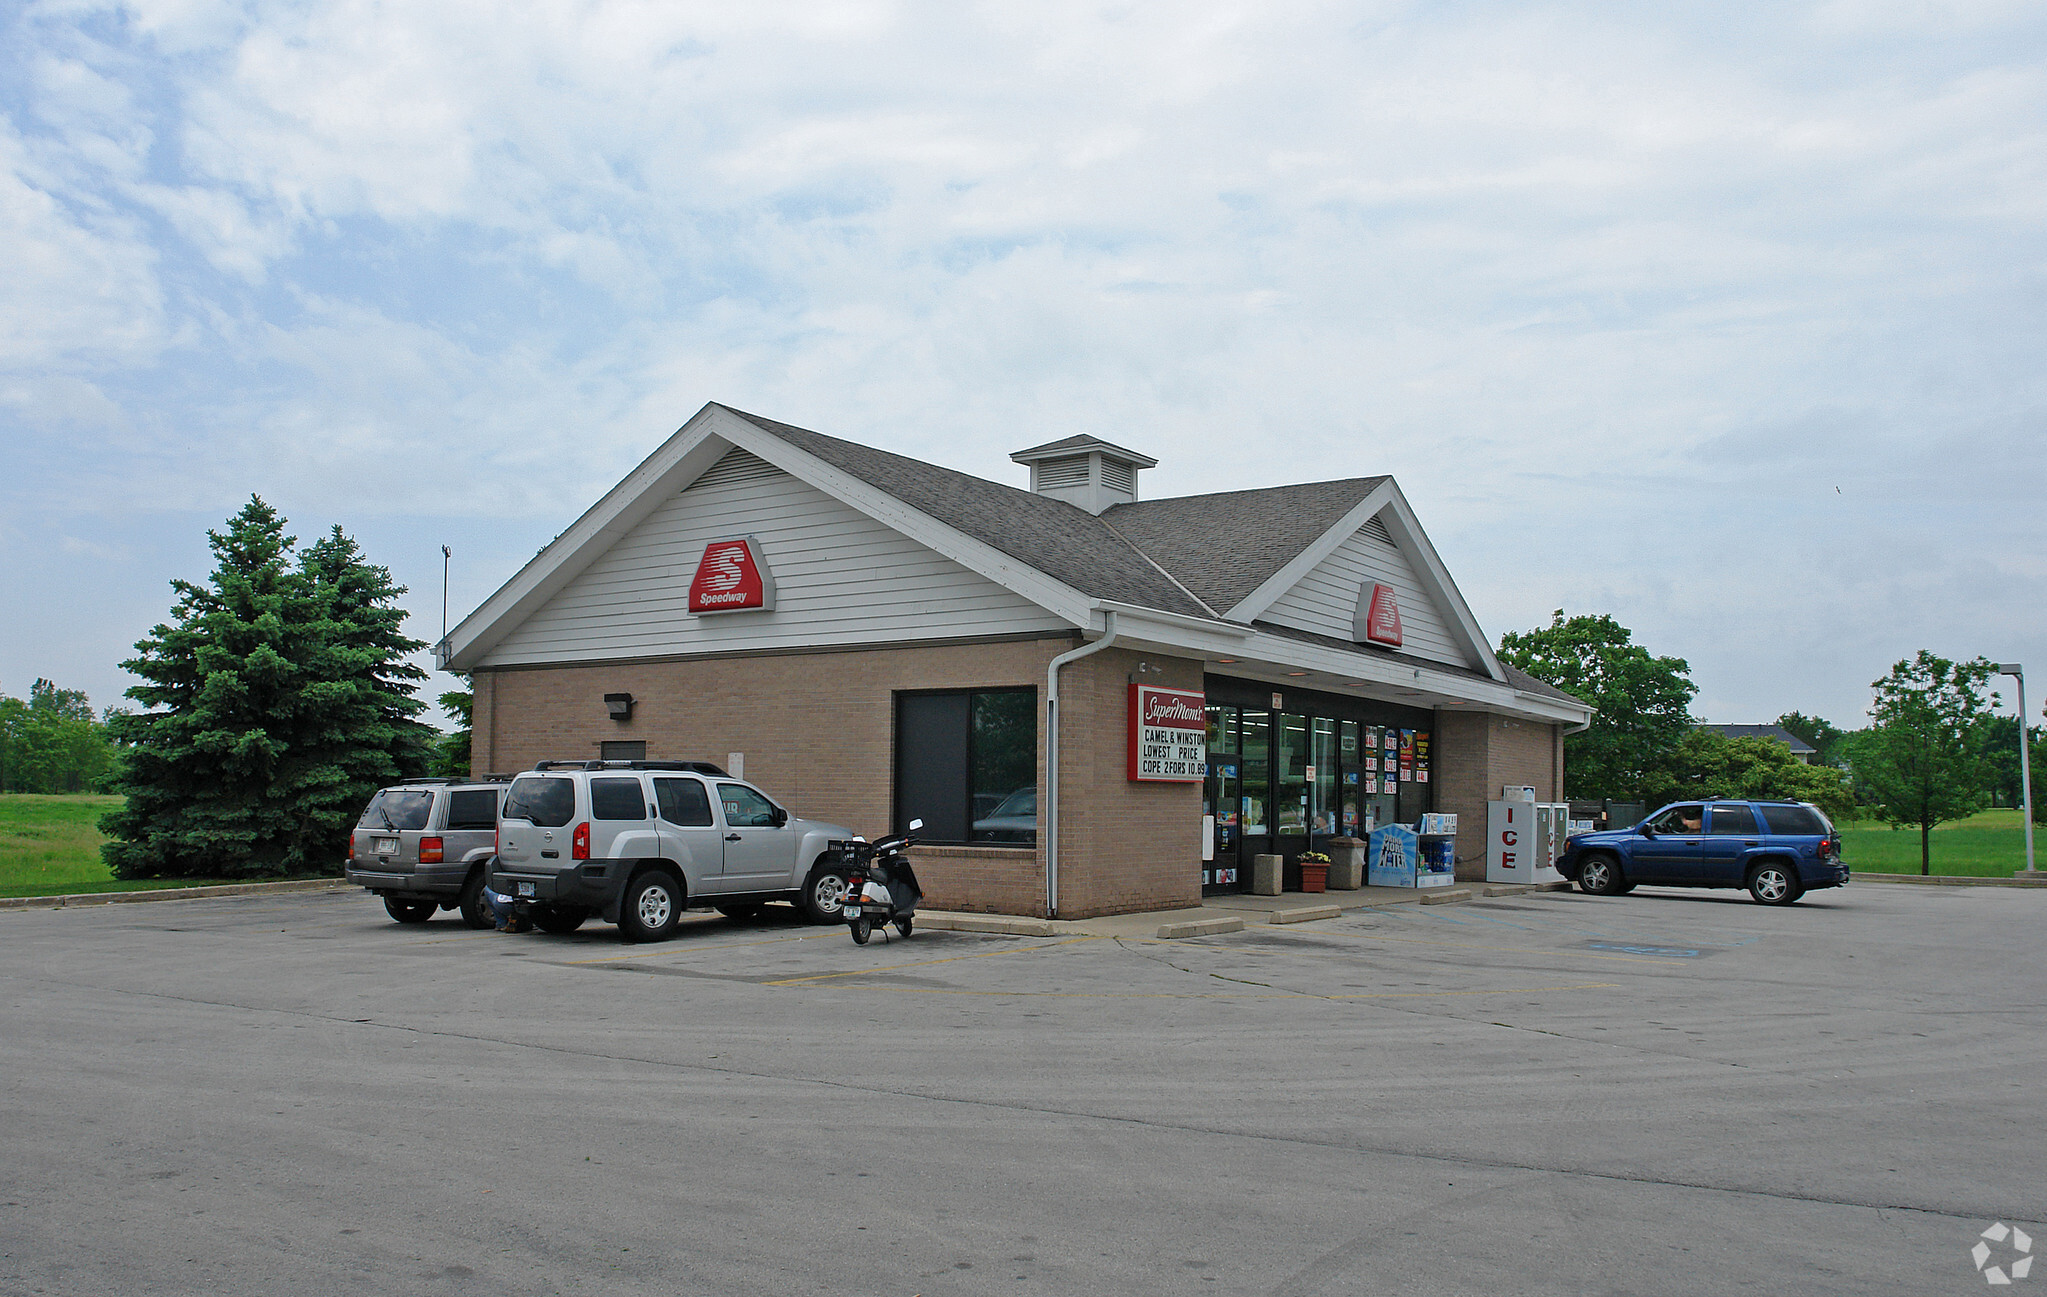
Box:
471, 636, 1202, 919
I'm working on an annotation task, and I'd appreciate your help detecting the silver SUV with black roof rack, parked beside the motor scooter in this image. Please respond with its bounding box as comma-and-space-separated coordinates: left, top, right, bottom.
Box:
491, 761, 854, 941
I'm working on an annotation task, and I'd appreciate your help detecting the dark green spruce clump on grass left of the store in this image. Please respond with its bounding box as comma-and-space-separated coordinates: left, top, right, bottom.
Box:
100, 497, 432, 878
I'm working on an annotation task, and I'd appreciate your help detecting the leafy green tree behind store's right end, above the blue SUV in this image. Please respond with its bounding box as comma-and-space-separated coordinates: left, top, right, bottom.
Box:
1500, 610, 1699, 800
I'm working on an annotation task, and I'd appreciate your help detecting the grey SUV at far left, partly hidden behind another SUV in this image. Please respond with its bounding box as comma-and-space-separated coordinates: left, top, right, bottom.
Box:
348, 779, 506, 929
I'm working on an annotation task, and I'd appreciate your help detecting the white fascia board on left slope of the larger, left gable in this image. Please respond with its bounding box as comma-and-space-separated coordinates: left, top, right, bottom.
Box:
434, 403, 731, 671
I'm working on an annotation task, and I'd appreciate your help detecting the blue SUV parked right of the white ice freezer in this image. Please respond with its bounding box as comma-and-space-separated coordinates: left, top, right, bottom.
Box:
1556, 802, 1848, 904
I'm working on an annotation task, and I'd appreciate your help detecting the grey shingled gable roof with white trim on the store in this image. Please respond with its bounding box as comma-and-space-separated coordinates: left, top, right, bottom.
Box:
436, 401, 1586, 722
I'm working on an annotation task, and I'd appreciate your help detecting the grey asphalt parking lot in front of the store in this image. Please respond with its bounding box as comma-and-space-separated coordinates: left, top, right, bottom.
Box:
0, 886, 2047, 1297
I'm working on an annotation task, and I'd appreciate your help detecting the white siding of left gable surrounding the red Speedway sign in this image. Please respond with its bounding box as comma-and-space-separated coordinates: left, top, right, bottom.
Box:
481, 450, 1071, 667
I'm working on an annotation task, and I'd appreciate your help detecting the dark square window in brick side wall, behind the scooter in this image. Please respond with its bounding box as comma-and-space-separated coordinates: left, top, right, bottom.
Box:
895, 689, 1038, 847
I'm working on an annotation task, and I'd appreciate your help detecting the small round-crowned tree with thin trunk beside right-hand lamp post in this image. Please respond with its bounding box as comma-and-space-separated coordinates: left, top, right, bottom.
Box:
1848, 649, 1996, 874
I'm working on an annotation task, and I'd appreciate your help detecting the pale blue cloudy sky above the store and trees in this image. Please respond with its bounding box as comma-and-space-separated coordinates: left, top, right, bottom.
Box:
0, 0, 2047, 726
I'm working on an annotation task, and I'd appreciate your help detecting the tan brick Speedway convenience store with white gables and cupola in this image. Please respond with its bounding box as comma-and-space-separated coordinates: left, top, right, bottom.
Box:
436, 403, 1591, 919
